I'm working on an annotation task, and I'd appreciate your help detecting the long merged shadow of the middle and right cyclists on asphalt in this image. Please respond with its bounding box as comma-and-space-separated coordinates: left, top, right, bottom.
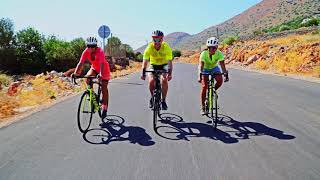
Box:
156, 113, 295, 144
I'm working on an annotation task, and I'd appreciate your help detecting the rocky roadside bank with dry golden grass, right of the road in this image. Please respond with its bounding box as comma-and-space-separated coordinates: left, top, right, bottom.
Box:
179, 31, 320, 78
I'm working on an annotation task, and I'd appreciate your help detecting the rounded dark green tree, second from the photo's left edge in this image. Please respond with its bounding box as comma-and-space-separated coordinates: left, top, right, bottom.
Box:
17, 27, 46, 74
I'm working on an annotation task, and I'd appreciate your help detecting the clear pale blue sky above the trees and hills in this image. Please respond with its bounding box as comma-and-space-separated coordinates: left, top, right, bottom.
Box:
0, 0, 261, 49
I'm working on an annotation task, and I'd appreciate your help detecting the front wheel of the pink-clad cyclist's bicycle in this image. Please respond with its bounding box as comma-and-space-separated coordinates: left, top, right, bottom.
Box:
78, 92, 93, 133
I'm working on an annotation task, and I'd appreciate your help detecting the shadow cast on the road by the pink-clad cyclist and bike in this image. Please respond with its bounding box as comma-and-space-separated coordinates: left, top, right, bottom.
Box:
83, 115, 155, 146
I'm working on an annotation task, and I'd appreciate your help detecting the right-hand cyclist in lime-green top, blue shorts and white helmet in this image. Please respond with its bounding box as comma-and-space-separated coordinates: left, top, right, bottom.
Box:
198, 37, 229, 115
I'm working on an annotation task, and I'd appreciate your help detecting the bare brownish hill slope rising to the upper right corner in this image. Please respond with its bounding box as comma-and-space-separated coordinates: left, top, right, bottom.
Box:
136, 0, 320, 50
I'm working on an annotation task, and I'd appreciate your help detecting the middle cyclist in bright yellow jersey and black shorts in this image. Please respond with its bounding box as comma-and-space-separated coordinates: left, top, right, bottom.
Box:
141, 30, 173, 110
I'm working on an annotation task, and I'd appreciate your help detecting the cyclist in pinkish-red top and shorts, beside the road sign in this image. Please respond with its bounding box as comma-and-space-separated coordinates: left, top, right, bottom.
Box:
75, 37, 110, 118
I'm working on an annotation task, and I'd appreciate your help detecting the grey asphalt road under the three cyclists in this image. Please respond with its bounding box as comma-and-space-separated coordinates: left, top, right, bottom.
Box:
0, 63, 320, 180
